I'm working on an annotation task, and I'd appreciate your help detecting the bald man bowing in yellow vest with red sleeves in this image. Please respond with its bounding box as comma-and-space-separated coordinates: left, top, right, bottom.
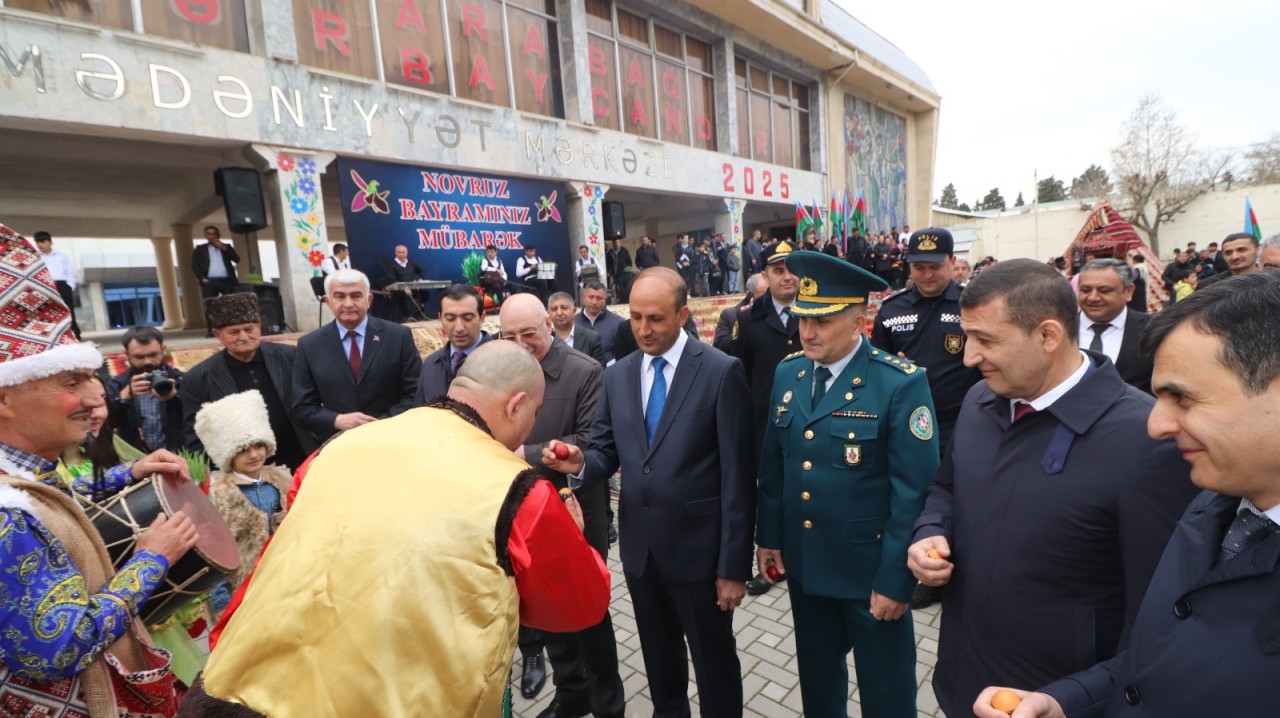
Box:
179, 342, 609, 718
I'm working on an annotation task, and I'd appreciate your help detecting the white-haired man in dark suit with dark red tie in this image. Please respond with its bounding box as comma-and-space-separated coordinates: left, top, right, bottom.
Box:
289, 269, 422, 443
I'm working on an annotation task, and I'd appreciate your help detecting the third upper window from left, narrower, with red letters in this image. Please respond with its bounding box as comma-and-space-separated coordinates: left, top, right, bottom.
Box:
585, 0, 716, 150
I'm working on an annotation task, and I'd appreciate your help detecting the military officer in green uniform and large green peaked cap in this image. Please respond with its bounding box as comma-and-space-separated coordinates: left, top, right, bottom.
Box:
756, 252, 938, 718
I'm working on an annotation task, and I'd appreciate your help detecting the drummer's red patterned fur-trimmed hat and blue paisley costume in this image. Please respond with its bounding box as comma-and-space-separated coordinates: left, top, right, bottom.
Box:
0, 225, 177, 718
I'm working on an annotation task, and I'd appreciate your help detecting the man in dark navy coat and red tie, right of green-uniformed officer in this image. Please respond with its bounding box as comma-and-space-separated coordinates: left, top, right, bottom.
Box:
908, 260, 1196, 715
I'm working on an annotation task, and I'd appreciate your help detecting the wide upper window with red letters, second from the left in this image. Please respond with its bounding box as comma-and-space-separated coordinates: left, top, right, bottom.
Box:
293, 0, 564, 116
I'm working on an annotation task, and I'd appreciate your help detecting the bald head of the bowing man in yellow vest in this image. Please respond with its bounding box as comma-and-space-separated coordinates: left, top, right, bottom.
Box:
449, 340, 544, 451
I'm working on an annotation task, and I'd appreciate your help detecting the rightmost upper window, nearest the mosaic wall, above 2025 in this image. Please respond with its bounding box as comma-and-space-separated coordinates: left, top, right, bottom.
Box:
733, 58, 810, 169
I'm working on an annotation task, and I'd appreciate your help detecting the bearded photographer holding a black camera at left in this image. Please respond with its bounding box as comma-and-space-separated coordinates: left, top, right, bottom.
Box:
106, 326, 182, 452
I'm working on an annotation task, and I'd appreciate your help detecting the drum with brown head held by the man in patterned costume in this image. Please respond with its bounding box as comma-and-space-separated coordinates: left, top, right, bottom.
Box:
77, 475, 239, 626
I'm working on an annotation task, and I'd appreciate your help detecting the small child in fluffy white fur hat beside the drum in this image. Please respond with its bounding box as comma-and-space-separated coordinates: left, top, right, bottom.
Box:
196, 390, 292, 613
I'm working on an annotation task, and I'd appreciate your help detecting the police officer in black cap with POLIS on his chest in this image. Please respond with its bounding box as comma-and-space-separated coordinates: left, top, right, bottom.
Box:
872, 227, 982, 608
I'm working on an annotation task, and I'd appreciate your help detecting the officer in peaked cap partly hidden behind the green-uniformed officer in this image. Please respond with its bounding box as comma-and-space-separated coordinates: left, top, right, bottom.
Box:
730, 241, 800, 596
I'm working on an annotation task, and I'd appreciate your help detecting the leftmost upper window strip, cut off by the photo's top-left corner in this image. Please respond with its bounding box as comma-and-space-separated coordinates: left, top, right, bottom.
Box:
0, 0, 248, 52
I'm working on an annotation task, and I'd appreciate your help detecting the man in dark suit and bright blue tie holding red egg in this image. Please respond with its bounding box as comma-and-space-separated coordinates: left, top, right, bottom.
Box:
543, 267, 755, 718
